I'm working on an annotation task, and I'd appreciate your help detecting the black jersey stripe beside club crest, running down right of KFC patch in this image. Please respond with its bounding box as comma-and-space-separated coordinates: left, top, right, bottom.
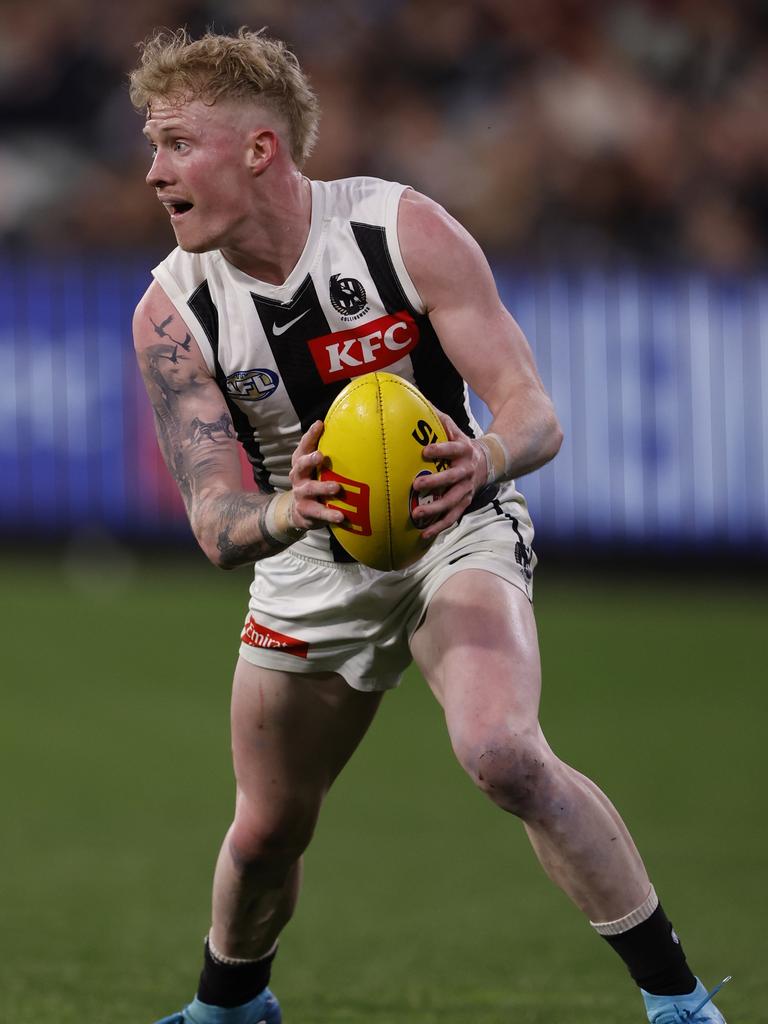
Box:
351, 221, 474, 437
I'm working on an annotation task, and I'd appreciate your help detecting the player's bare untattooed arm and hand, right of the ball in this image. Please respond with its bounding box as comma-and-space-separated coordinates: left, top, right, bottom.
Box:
397, 190, 562, 537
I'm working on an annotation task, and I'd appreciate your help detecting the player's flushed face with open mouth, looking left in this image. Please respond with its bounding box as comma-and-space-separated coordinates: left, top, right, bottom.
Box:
144, 99, 260, 252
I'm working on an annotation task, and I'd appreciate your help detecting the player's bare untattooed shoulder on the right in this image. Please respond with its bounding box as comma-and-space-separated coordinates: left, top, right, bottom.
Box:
397, 188, 496, 311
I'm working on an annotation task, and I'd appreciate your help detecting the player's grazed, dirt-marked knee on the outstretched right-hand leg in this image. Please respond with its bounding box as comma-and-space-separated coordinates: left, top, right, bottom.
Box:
456, 735, 559, 820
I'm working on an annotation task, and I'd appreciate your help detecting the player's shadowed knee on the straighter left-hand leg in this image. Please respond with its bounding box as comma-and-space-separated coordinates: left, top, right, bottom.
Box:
226, 799, 317, 876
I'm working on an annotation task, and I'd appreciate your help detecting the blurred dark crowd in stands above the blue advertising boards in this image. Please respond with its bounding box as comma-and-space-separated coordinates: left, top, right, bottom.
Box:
0, 0, 768, 271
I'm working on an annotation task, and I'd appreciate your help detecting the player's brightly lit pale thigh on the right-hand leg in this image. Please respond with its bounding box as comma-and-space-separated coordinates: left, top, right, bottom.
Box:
411, 569, 541, 745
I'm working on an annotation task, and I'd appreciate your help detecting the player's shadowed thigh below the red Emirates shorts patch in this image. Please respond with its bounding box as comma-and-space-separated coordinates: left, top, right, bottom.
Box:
231, 658, 381, 819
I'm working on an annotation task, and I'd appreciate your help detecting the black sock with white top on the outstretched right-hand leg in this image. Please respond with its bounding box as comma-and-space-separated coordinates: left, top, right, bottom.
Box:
603, 903, 696, 995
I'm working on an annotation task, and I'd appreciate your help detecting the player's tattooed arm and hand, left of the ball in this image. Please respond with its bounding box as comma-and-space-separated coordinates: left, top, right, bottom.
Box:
133, 283, 342, 568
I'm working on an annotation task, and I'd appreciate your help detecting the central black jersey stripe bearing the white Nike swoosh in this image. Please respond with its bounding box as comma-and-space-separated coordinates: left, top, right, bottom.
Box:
251, 274, 346, 433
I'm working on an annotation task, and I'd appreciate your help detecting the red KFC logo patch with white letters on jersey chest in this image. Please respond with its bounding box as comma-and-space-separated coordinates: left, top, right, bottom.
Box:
309, 309, 419, 384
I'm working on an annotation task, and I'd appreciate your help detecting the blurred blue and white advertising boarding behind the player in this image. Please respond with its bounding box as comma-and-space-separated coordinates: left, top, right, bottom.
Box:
0, 256, 768, 551
